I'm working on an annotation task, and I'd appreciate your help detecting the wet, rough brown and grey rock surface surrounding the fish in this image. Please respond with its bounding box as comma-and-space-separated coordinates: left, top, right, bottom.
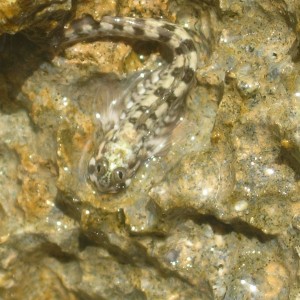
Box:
0, 0, 300, 299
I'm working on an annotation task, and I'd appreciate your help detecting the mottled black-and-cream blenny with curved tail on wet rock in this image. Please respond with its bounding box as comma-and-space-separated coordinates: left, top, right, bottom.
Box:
61, 15, 197, 193
